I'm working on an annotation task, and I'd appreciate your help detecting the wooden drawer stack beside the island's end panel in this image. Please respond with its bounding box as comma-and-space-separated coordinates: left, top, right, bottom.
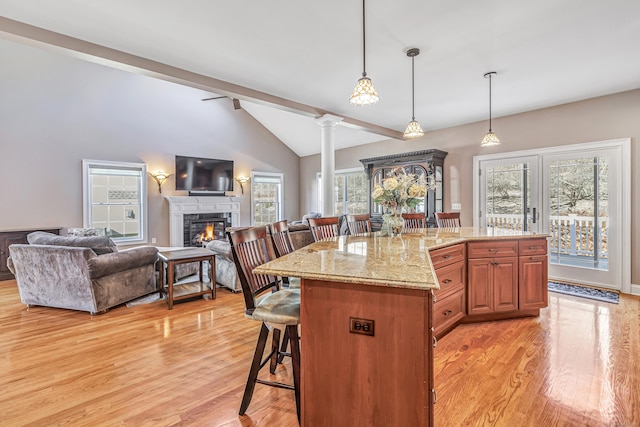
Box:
429, 243, 467, 338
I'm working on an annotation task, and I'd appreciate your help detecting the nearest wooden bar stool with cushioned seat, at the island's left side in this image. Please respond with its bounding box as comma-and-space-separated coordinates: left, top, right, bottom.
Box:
227, 227, 300, 421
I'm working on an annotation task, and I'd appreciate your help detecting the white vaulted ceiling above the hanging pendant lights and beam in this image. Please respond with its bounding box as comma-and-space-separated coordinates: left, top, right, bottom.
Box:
0, 0, 640, 156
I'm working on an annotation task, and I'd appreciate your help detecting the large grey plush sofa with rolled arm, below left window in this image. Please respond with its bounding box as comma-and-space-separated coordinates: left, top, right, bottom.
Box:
8, 232, 158, 314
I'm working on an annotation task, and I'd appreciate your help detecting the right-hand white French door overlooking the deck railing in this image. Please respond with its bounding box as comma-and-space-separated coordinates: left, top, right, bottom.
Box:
542, 149, 622, 290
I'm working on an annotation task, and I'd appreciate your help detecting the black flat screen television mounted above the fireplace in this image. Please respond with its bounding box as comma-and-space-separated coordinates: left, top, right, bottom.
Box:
176, 156, 233, 194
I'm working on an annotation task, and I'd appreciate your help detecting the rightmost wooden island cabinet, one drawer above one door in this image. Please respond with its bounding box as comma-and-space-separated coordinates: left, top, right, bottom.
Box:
518, 239, 549, 310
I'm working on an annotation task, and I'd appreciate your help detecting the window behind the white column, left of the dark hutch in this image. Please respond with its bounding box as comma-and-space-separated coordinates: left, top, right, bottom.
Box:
318, 168, 369, 215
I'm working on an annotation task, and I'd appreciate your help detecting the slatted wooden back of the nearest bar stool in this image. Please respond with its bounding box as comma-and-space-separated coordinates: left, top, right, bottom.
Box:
227, 227, 280, 312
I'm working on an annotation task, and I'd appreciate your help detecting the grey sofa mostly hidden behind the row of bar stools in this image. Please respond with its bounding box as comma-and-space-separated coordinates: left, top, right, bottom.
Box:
206, 223, 313, 292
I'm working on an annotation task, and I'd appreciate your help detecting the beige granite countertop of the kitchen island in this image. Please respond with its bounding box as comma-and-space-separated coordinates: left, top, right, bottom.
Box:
254, 227, 548, 290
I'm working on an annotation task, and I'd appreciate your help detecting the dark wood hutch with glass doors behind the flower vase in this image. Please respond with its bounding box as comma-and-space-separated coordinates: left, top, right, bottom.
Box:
360, 149, 448, 227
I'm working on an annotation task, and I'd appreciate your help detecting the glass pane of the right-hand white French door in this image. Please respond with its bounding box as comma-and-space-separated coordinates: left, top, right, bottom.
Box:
549, 157, 609, 270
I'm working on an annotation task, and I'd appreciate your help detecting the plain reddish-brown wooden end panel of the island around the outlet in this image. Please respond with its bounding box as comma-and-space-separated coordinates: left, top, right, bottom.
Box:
300, 279, 435, 427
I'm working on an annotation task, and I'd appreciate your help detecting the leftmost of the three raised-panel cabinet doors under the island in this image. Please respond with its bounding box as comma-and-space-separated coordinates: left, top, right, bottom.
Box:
467, 258, 493, 315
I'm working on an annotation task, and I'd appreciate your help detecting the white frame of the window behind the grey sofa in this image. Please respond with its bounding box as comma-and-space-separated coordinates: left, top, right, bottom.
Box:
82, 159, 148, 245
